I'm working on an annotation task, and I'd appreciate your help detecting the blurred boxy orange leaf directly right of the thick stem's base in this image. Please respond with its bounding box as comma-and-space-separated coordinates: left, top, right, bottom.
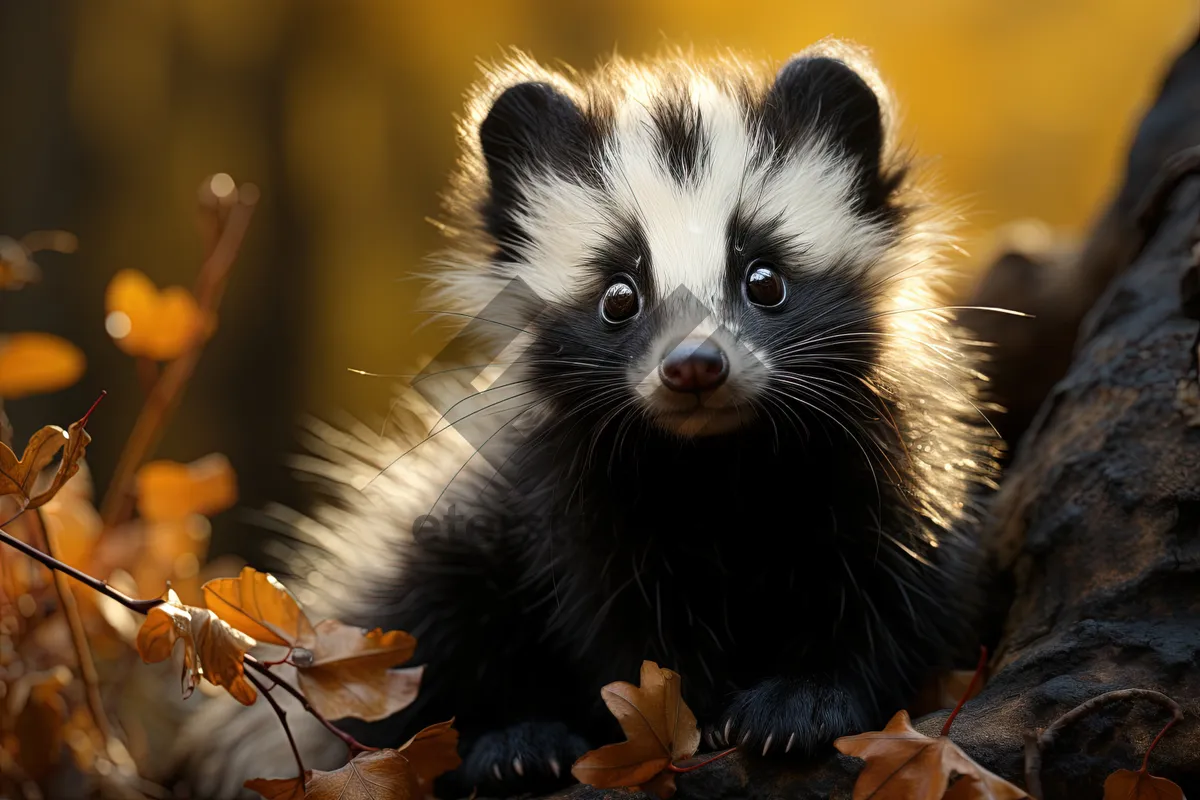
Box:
137, 453, 238, 522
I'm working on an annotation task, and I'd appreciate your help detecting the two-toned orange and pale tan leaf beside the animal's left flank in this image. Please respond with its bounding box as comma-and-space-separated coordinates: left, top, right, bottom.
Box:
293, 619, 424, 722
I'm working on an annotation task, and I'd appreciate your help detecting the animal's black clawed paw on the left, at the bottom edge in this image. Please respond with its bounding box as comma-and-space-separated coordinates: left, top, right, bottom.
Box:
460, 722, 588, 798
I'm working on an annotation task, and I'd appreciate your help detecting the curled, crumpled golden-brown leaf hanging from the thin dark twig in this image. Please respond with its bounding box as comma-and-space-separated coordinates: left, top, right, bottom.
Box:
137, 590, 257, 705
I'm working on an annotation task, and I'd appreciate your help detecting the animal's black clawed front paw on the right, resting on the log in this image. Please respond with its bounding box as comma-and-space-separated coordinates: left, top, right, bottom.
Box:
704, 678, 870, 758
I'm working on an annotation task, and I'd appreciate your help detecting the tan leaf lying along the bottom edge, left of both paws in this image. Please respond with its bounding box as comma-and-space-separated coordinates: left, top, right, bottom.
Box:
244, 750, 412, 800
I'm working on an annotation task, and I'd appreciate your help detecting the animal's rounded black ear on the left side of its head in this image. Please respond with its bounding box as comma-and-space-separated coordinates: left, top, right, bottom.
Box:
479, 82, 587, 214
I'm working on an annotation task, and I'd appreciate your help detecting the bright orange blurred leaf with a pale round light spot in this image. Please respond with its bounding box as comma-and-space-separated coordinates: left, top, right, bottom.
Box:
104, 270, 208, 361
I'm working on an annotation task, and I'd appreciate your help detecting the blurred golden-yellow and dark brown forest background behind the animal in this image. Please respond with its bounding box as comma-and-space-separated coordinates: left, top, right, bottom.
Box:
0, 0, 1198, 563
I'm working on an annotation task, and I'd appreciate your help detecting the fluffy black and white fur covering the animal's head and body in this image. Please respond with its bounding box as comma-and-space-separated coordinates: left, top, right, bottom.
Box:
180, 41, 996, 796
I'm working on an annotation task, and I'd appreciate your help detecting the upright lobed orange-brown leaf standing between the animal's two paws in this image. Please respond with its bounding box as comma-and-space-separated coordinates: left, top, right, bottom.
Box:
571, 661, 700, 798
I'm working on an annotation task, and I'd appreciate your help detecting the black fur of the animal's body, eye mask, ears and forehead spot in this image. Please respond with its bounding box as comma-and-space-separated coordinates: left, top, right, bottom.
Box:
321, 51, 971, 796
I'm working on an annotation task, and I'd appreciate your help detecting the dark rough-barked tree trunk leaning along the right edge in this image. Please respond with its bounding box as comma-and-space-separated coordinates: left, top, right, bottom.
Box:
540, 29, 1200, 800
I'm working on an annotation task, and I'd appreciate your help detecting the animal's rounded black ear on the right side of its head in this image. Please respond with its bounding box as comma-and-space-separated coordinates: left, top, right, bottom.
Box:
763, 55, 884, 175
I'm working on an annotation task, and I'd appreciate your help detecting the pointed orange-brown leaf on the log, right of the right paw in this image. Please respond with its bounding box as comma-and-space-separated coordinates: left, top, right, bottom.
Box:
834, 711, 1030, 800
